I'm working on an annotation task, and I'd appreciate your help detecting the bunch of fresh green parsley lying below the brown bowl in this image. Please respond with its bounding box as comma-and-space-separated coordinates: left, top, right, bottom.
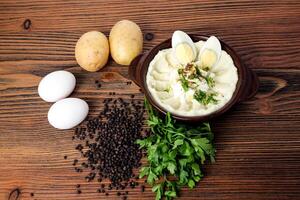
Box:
137, 100, 215, 200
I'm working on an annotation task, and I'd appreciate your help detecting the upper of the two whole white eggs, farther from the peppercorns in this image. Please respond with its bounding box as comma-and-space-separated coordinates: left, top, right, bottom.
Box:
38, 70, 76, 102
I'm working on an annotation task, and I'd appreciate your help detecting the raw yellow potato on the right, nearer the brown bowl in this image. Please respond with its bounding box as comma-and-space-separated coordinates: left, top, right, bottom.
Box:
109, 20, 143, 65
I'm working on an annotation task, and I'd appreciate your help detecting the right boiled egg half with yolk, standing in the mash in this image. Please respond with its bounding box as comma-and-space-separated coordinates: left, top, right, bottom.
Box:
198, 36, 222, 69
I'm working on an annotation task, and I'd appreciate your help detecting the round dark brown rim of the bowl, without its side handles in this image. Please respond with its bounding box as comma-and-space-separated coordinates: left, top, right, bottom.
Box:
139, 34, 247, 122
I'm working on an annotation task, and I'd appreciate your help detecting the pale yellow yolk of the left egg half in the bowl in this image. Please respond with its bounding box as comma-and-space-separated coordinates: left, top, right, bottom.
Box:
175, 43, 195, 64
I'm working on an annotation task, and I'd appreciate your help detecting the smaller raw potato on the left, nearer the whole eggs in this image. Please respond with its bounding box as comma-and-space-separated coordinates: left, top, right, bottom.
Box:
75, 31, 109, 72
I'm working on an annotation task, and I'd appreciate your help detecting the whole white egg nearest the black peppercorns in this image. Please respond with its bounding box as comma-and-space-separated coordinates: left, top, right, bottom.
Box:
48, 98, 89, 129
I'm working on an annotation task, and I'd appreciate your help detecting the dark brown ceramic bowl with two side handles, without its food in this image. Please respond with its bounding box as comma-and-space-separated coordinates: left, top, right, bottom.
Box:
129, 35, 259, 123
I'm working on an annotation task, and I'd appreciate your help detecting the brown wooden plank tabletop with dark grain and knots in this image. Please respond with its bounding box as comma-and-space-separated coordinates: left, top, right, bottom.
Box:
0, 0, 300, 200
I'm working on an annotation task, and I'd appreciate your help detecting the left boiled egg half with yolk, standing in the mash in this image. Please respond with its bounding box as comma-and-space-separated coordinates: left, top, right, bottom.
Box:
172, 31, 197, 65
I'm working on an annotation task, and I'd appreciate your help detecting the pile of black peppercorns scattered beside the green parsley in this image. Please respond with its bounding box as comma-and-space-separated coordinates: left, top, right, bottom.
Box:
73, 97, 144, 199
